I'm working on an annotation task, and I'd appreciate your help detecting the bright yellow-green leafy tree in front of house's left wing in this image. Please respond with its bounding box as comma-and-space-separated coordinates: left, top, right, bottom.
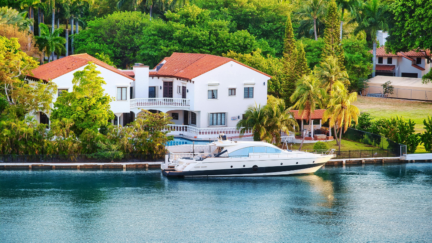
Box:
51, 63, 114, 136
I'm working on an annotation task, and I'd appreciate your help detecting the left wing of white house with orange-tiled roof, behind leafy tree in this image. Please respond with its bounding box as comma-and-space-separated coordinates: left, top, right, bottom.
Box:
26, 54, 135, 124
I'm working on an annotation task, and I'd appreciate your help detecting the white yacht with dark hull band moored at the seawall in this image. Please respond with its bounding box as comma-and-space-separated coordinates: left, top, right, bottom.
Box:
162, 135, 333, 177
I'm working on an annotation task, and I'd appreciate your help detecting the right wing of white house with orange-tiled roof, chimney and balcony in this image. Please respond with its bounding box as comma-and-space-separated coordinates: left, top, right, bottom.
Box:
122, 53, 271, 138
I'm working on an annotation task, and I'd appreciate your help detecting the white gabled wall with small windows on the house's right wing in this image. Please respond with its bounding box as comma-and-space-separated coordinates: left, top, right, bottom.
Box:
191, 62, 270, 128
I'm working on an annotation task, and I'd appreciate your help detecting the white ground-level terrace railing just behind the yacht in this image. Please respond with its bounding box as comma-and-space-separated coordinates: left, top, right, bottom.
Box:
164, 125, 252, 139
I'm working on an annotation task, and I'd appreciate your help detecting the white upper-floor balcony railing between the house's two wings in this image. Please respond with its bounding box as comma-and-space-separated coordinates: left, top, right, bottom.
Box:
130, 98, 190, 108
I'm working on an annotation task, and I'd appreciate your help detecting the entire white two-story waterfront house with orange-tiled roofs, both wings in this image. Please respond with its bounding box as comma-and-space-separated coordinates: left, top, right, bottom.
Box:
28, 53, 271, 139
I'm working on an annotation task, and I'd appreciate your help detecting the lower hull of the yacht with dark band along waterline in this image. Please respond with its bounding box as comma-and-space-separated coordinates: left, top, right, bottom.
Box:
162, 162, 325, 177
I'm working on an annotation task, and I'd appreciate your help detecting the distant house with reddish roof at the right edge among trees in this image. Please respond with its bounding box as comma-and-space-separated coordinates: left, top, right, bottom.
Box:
375, 47, 431, 78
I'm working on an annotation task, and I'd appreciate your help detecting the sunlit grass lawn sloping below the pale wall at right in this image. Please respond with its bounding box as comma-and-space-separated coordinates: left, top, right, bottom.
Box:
354, 96, 432, 132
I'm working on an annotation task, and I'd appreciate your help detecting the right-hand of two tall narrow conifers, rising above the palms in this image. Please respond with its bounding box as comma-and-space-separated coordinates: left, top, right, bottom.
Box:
322, 0, 345, 71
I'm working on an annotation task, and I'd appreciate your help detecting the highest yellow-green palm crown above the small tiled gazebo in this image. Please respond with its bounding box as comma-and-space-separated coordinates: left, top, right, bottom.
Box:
315, 56, 349, 95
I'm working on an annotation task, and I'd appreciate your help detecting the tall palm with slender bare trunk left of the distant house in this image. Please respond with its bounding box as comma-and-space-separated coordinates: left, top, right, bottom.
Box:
350, 0, 390, 77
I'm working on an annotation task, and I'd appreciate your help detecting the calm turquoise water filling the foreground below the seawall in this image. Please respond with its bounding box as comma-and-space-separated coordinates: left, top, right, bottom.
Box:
0, 164, 432, 242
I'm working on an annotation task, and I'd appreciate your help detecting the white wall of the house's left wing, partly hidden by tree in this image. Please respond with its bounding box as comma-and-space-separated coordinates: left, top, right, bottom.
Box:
52, 65, 134, 113
